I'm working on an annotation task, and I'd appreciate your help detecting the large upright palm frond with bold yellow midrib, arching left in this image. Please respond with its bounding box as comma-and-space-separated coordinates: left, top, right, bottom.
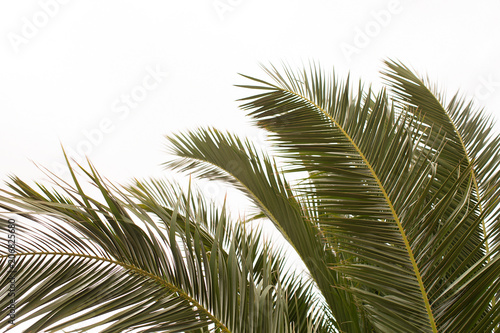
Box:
236, 63, 444, 331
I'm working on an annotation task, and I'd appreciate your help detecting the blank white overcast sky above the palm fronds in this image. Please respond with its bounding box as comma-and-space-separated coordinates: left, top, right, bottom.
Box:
0, 0, 500, 200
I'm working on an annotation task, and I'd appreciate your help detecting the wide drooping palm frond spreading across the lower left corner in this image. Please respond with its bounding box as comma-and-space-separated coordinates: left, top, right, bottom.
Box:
0, 156, 328, 332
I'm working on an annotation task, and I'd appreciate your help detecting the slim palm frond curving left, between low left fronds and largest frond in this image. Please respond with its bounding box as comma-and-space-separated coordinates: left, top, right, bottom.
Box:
166, 129, 364, 331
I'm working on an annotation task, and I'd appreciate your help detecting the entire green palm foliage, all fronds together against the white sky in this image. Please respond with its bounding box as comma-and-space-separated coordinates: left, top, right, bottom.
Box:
0, 61, 500, 332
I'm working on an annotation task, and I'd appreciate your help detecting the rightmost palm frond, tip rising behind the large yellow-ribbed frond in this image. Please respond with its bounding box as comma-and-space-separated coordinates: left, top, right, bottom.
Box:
383, 61, 500, 246
